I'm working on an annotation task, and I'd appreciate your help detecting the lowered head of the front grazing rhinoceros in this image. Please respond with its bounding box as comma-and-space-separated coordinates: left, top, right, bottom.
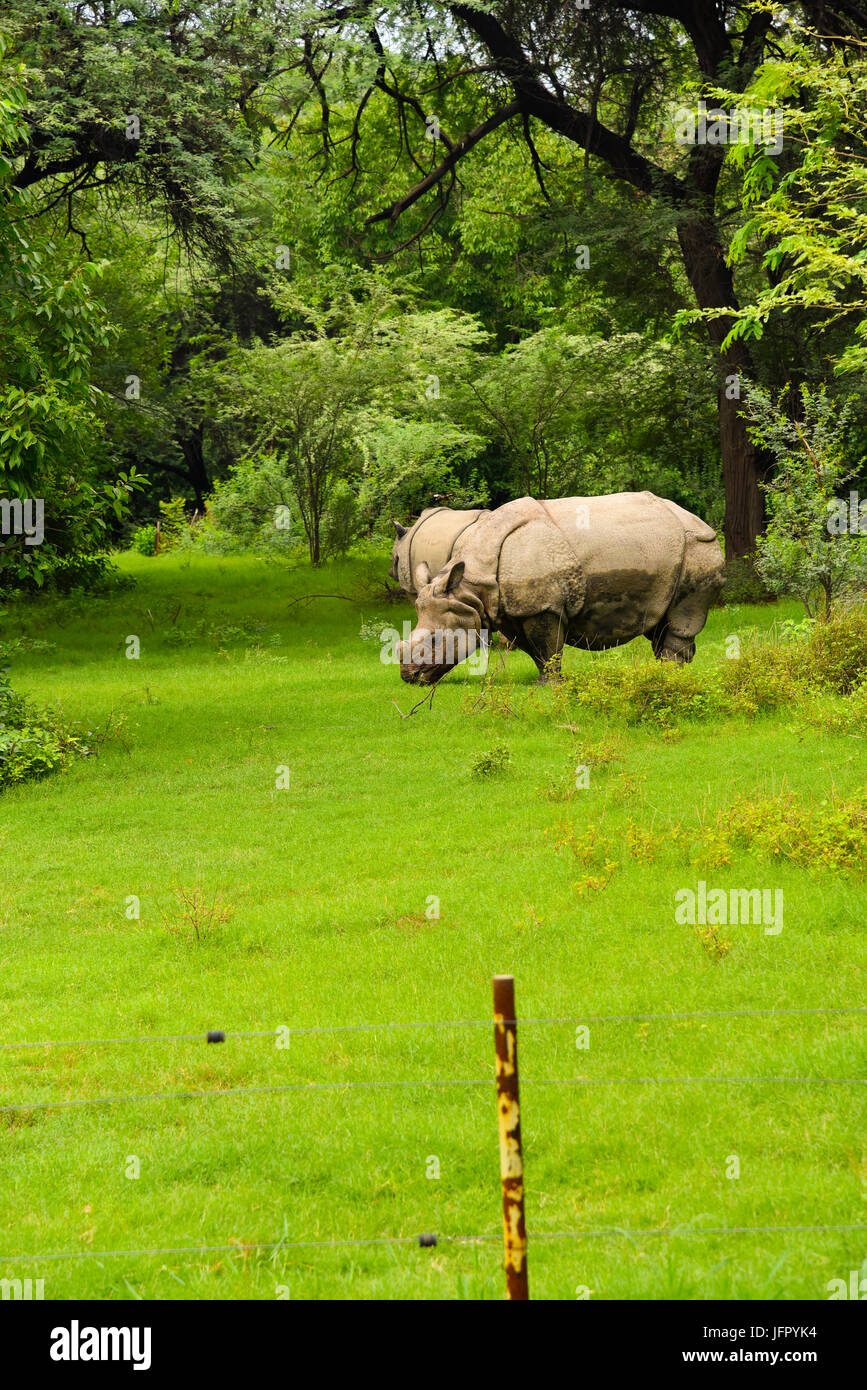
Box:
400, 560, 484, 685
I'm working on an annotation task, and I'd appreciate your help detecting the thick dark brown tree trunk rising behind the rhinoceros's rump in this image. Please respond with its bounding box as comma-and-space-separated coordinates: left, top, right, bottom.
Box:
678, 217, 767, 560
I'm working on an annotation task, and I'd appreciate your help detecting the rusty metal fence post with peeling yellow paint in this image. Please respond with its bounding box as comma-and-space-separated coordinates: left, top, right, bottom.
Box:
493, 974, 529, 1300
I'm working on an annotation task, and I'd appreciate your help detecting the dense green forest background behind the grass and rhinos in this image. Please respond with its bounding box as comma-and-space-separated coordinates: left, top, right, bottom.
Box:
0, 0, 867, 592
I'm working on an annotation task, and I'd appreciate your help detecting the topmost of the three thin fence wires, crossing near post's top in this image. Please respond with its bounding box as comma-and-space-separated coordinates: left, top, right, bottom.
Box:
0, 1005, 867, 1051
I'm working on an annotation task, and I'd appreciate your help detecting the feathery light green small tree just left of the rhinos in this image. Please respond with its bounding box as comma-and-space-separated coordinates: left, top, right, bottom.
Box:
206, 267, 485, 563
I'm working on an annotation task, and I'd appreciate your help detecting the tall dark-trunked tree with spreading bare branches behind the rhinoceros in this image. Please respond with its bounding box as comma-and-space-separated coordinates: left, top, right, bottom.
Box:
293, 0, 867, 556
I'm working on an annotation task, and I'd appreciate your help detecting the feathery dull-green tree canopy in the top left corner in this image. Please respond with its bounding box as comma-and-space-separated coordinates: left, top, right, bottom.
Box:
4, 0, 261, 260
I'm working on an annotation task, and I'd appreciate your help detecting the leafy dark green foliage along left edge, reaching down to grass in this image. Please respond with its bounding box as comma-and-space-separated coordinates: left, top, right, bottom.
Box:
0, 28, 142, 591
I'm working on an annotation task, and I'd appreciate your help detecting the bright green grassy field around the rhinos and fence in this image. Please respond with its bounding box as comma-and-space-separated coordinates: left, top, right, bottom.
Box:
0, 556, 867, 1298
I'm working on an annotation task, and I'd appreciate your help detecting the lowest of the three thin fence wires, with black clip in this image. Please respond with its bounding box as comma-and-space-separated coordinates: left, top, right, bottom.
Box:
0, 1223, 867, 1265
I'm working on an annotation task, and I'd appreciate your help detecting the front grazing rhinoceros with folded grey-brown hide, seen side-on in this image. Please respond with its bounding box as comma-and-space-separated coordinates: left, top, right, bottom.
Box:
396, 492, 724, 684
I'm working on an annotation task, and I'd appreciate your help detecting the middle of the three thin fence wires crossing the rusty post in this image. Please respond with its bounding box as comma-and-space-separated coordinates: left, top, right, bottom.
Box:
0, 1074, 867, 1115
